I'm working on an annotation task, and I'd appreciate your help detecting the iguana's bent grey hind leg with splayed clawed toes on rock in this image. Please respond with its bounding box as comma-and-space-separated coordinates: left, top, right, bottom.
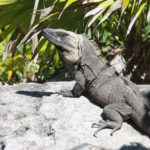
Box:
92, 102, 131, 137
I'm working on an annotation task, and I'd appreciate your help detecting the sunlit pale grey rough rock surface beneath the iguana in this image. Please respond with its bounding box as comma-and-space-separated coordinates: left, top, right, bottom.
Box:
0, 81, 150, 150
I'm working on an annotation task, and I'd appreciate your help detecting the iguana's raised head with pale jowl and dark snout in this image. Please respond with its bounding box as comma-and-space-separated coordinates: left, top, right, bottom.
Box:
43, 28, 80, 64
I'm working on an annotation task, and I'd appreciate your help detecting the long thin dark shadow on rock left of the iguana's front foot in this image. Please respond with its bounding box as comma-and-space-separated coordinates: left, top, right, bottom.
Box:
16, 91, 57, 97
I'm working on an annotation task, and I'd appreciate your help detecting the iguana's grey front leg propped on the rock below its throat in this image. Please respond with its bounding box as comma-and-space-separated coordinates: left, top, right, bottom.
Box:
59, 71, 85, 97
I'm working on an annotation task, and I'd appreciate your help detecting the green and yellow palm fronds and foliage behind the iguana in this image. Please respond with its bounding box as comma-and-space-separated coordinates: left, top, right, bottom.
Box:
0, 0, 150, 84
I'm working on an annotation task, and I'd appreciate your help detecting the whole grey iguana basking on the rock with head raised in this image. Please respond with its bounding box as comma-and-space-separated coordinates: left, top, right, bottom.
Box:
43, 29, 150, 136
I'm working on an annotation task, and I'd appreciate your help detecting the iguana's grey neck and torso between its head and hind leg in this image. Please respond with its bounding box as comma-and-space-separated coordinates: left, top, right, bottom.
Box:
78, 35, 144, 106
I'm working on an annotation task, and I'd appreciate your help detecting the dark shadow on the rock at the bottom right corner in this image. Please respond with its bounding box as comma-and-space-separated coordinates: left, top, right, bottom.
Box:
119, 143, 150, 150
